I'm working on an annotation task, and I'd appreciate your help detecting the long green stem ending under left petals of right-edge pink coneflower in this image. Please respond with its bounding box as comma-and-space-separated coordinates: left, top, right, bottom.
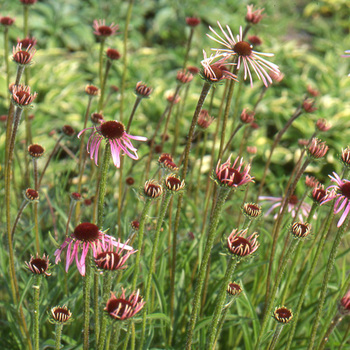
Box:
286, 205, 334, 350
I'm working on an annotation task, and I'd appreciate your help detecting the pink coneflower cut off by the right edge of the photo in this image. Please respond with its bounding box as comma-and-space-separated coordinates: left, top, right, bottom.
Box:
321, 172, 350, 227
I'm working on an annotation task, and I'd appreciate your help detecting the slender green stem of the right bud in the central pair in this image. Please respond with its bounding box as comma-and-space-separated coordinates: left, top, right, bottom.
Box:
139, 191, 172, 349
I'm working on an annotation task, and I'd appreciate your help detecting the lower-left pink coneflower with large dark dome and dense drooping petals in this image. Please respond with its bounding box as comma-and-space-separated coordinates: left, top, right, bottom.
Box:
54, 222, 132, 276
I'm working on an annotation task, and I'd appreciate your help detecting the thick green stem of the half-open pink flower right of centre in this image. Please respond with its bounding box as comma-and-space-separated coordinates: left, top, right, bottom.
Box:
186, 187, 230, 350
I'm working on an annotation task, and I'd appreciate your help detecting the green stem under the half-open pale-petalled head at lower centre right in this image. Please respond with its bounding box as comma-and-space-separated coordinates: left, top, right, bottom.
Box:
206, 257, 239, 350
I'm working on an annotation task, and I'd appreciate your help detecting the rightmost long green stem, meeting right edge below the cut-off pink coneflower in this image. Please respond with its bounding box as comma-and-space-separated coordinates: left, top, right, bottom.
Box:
308, 216, 350, 350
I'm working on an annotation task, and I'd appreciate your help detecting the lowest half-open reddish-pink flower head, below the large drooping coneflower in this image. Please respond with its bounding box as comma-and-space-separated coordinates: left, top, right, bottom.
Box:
104, 288, 145, 321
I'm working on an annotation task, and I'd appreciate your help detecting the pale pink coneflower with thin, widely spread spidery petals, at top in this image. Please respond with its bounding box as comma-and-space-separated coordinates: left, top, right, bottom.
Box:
207, 22, 279, 87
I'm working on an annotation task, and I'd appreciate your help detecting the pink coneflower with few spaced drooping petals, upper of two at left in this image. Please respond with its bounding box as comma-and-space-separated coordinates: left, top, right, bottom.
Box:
78, 120, 147, 168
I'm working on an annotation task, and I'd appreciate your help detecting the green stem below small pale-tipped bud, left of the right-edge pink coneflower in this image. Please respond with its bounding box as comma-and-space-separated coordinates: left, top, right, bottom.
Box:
255, 238, 300, 350
